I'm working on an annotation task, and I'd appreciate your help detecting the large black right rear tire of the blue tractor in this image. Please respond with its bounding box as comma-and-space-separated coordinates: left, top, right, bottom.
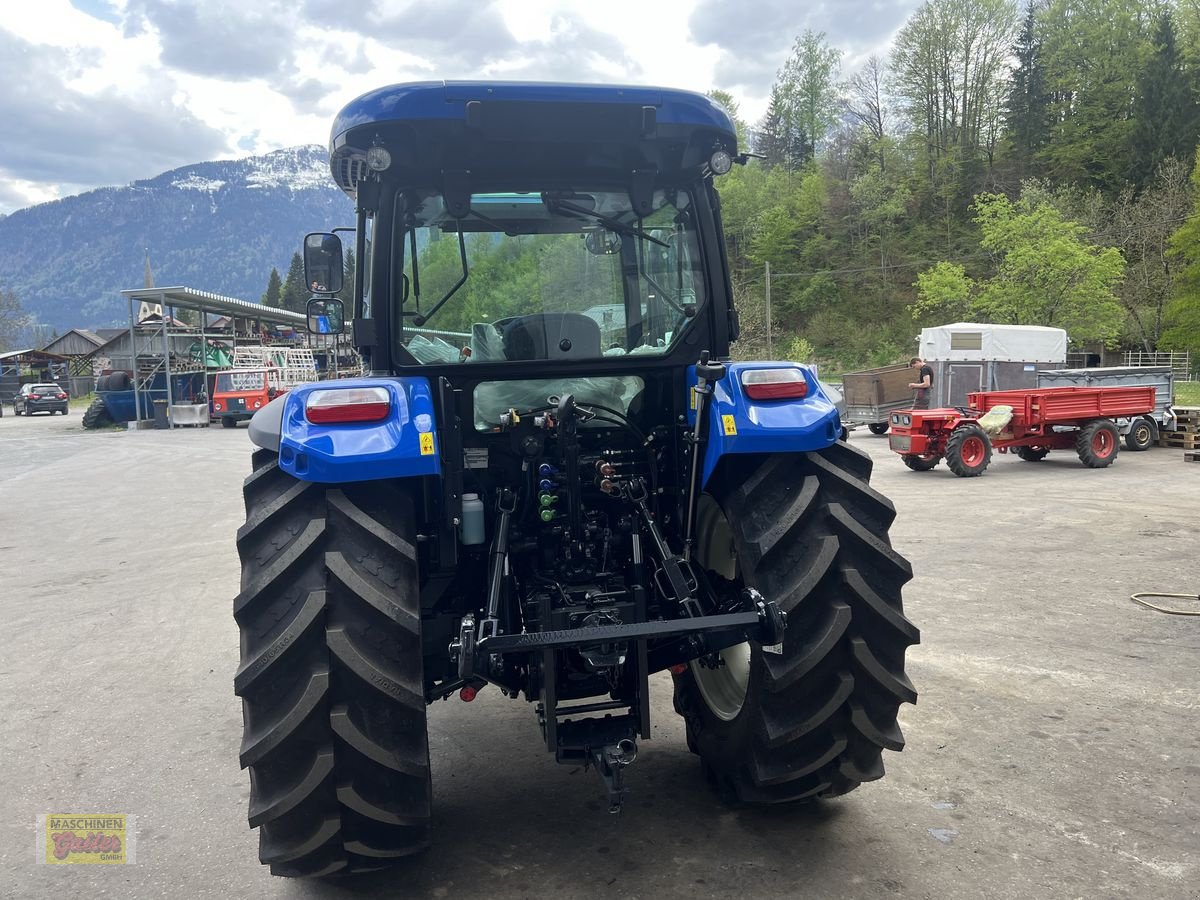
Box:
674, 443, 919, 804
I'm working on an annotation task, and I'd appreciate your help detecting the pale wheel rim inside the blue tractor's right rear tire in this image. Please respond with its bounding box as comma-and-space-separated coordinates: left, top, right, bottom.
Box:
690, 494, 750, 721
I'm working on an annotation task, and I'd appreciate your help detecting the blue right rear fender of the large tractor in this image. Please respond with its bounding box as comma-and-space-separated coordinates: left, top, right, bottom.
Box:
688, 362, 841, 485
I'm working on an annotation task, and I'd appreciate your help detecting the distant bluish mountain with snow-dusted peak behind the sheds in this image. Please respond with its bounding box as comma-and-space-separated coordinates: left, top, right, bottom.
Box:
0, 145, 354, 331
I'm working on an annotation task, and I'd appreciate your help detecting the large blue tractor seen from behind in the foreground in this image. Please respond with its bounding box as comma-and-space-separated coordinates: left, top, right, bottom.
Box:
234, 82, 918, 876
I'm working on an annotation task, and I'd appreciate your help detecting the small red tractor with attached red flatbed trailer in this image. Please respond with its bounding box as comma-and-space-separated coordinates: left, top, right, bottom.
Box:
889, 385, 1154, 478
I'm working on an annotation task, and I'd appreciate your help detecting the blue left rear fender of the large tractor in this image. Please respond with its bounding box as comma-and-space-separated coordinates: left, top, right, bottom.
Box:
280, 378, 442, 484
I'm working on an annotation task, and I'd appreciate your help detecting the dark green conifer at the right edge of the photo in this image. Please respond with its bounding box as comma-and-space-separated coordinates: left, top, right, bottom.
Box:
1130, 10, 1198, 187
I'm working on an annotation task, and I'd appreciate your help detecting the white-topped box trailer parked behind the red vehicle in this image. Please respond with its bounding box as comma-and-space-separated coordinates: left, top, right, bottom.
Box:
917, 322, 1067, 408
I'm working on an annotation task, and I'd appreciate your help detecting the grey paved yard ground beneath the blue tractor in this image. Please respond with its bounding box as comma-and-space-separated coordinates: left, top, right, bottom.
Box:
0, 414, 1200, 900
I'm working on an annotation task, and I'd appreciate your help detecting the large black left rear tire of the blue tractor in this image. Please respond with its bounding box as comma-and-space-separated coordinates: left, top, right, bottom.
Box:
234, 450, 431, 876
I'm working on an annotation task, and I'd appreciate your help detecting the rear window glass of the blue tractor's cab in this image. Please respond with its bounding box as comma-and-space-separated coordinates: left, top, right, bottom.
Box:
397, 190, 704, 364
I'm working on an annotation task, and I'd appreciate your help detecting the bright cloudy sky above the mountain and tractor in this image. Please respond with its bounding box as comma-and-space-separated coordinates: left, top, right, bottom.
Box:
0, 0, 917, 214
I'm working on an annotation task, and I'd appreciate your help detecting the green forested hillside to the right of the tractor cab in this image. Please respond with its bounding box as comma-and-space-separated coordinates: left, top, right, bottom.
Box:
710, 0, 1200, 371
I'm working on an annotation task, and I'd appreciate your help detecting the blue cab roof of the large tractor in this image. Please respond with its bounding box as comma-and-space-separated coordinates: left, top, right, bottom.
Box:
330, 82, 737, 197
